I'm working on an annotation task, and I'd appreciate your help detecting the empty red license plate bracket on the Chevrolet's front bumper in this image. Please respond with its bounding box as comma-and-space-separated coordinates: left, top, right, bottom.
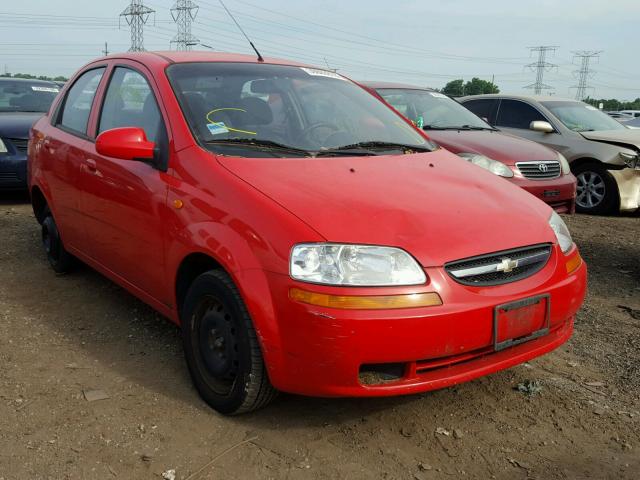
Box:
493, 293, 551, 351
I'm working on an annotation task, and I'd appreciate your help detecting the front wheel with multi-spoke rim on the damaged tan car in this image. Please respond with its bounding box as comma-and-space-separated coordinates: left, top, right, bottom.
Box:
573, 162, 619, 215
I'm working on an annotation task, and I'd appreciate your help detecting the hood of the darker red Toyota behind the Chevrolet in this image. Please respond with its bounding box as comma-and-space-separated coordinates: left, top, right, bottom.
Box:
426, 130, 558, 165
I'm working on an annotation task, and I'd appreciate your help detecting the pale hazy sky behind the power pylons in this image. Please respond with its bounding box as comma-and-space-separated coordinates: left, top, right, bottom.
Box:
0, 0, 640, 100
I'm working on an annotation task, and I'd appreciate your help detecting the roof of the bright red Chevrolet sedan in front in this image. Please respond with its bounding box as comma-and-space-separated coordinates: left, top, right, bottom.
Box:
97, 50, 312, 70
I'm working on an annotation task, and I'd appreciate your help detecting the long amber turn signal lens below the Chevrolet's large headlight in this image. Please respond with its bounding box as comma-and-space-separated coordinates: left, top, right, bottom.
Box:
289, 288, 442, 310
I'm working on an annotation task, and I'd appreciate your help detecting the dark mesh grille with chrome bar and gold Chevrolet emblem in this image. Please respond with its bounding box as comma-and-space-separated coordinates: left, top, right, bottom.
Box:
444, 244, 551, 286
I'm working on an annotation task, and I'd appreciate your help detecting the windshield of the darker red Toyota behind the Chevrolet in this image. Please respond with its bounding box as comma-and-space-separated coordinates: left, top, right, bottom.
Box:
377, 88, 492, 128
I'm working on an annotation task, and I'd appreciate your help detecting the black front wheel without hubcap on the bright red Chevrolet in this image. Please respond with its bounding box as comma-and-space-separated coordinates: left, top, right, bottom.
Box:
181, 270, 277, 415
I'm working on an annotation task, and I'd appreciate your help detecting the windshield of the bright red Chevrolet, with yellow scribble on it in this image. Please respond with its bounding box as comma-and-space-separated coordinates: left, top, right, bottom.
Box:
167, 62, 432, 156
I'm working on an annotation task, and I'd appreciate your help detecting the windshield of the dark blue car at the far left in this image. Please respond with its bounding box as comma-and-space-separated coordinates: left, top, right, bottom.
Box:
0, 80, 60, 113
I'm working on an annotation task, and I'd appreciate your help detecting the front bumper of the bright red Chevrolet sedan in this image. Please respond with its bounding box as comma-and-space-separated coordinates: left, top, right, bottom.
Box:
263, 248, 586, 397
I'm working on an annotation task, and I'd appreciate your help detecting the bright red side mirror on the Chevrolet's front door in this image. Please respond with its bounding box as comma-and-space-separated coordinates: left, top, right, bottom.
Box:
96, 127, 156, 161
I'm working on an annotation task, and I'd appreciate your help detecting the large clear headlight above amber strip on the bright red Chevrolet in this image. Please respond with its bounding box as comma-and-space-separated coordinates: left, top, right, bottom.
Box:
289, 243, 427, 286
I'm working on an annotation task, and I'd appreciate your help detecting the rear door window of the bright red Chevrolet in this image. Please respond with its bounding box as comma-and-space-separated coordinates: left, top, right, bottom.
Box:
58, 67, 105, 135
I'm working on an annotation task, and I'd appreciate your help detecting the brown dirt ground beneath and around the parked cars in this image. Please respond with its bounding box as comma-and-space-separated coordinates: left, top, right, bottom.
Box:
0, 195, 640, 480
